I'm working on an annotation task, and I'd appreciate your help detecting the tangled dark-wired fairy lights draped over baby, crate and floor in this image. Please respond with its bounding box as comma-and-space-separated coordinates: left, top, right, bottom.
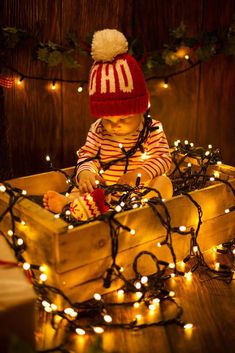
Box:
0, 114, 235, 352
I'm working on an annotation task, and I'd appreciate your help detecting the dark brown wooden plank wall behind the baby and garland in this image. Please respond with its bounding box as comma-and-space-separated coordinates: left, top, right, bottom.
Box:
0, 0, 235, 179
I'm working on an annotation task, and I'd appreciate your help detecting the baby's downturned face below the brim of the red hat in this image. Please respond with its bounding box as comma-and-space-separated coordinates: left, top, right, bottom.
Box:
102, 114, 143, 136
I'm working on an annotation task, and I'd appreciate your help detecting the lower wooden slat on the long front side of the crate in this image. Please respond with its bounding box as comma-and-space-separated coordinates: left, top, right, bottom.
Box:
53, 213, 235, 300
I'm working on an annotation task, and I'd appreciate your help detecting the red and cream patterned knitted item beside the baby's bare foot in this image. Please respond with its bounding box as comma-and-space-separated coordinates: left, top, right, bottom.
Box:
69, 188, 109, 221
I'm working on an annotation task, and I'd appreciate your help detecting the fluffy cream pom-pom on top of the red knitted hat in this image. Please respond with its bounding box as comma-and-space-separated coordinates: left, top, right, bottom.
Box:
91, 29, 128, 62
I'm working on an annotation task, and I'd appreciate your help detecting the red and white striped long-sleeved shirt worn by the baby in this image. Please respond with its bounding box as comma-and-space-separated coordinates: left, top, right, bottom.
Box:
77, 119, 171, 185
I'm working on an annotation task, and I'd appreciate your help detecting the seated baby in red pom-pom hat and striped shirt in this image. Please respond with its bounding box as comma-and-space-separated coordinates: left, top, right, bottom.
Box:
43, 29, 172, 219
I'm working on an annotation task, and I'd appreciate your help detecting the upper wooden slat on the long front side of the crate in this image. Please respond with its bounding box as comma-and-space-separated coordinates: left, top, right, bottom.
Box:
56, 180, 235, 273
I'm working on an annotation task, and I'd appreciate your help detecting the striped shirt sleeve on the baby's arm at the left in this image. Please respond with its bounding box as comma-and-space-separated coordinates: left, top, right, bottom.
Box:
77, 119, 102, 175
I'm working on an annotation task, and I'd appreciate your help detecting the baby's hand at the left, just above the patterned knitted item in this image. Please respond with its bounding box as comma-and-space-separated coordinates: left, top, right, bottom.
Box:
78, 170, 105, 194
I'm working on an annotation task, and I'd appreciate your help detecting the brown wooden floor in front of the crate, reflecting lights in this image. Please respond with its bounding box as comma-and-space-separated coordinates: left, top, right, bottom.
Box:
36, 251, 235, 353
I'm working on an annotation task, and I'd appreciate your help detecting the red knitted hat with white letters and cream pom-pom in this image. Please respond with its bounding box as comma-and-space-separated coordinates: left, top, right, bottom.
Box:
89, 29, 149, 117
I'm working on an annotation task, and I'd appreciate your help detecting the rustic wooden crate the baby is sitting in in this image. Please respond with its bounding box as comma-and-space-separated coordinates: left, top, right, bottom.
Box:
0, 165, 235, 301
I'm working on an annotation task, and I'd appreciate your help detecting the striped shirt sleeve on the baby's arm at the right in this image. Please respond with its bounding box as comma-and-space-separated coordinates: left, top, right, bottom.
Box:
142, 120, 171, 179
